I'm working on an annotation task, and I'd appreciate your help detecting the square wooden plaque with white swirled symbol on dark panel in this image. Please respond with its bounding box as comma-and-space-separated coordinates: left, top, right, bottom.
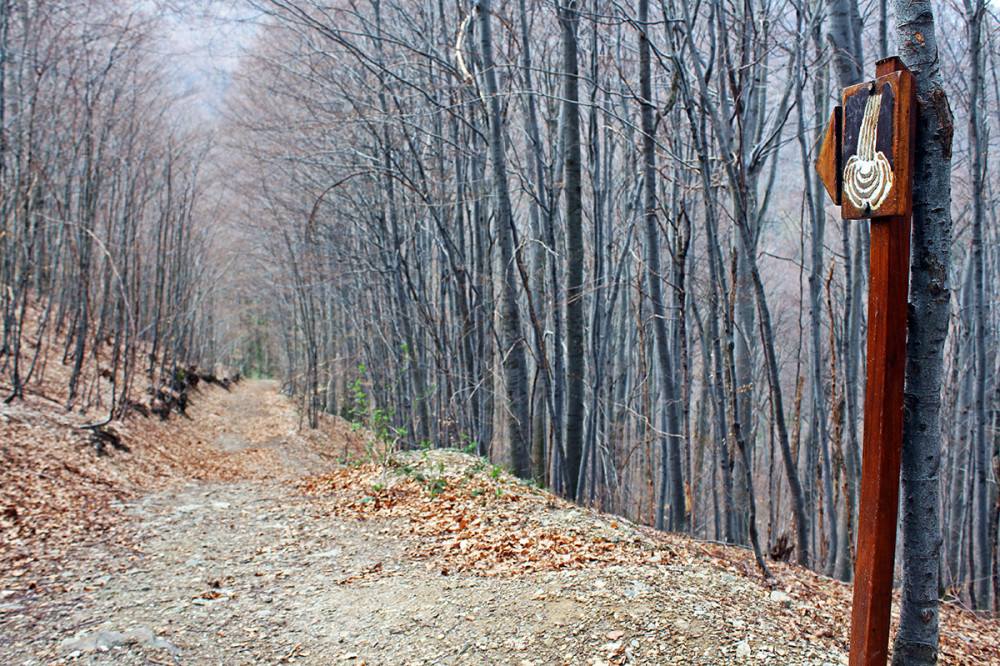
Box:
838, 69, 915, 220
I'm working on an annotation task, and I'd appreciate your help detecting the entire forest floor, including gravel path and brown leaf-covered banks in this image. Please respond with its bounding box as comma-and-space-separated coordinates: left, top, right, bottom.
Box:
0, 381, 1000, 666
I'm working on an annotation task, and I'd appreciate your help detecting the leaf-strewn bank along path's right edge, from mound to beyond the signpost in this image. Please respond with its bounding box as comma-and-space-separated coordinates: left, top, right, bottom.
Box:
299, 450, 1000, 666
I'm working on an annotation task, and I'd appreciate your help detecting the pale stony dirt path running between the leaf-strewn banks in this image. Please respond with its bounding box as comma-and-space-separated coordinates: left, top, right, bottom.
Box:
0, 382, 960, 666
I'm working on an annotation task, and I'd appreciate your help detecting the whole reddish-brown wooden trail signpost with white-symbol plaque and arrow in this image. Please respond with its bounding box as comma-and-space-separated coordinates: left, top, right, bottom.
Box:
816, 57, 917, 666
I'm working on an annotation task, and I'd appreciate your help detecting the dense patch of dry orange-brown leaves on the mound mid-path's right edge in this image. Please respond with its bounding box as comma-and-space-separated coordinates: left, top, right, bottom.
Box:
302, 451, 670, 576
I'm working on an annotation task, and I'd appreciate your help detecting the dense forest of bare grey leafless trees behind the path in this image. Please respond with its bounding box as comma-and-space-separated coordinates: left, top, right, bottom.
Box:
0, 0, 1000, 664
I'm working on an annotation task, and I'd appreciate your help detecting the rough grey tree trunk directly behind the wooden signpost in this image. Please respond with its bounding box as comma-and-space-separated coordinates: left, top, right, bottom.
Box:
892, 0, 954, 666
